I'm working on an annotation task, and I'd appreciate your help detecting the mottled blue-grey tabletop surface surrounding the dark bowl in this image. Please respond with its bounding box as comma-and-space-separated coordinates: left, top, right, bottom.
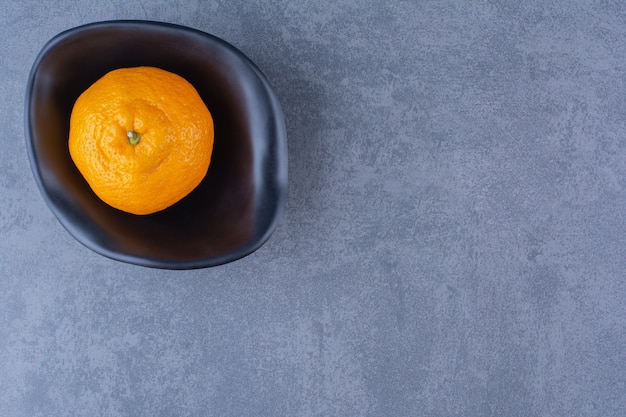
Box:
0, 0, 626, 417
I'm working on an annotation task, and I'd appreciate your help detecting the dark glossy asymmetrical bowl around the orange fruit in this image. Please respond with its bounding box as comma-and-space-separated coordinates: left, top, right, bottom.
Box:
26, 21, 287, 269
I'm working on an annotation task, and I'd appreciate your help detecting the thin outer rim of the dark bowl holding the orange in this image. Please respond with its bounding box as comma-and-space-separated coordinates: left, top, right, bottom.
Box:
24, 19, 288, 270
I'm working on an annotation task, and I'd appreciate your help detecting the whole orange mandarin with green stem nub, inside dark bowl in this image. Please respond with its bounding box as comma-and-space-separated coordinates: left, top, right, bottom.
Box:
68, 67, 214, 215
